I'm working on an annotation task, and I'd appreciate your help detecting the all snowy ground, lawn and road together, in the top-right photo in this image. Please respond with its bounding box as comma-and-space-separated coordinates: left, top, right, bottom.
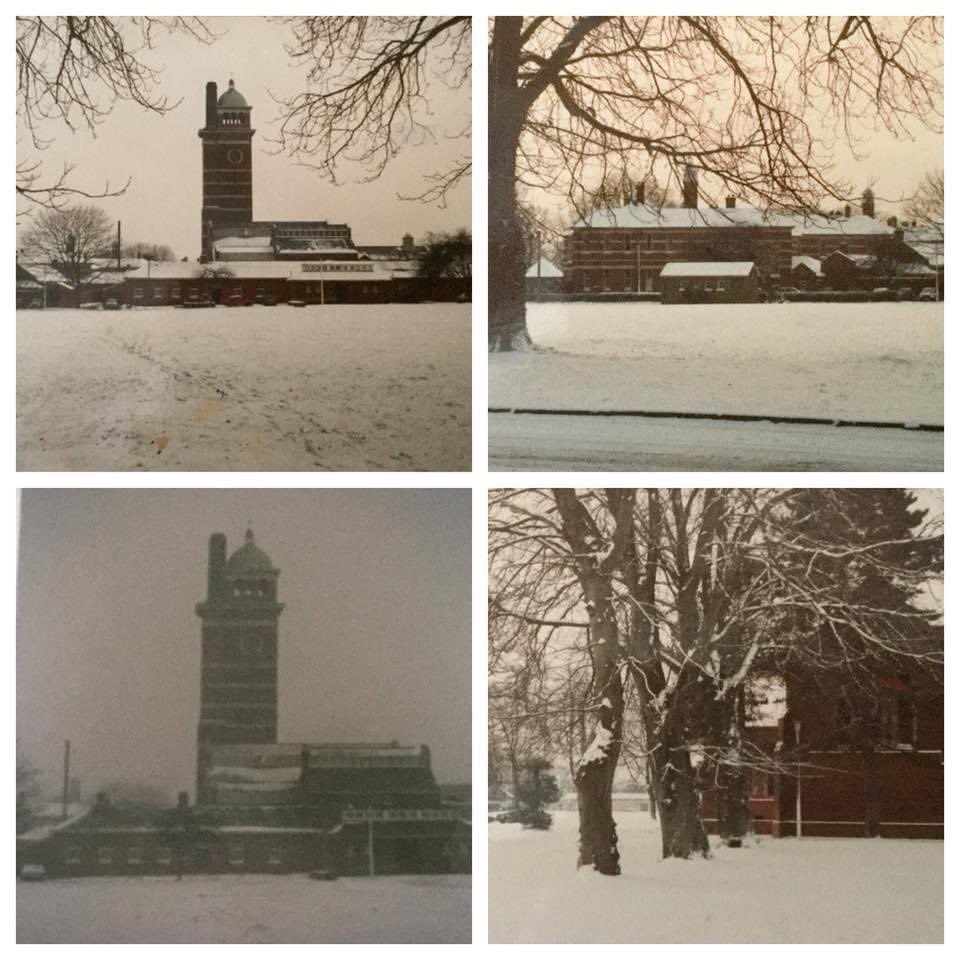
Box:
489, 302, 943, 470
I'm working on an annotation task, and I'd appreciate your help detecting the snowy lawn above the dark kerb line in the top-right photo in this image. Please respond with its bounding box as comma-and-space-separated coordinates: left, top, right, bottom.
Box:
489, 302, 943, 424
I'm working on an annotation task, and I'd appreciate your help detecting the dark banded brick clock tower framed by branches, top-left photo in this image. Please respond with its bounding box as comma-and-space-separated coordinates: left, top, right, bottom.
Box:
198, 80, 256, 261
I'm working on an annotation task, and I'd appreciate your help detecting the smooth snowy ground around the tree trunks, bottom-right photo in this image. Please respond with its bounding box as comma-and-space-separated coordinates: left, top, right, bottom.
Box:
489, 812, 943, 943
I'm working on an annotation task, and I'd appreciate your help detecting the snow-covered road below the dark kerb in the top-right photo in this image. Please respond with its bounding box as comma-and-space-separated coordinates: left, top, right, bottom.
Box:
488, 413, 943, 471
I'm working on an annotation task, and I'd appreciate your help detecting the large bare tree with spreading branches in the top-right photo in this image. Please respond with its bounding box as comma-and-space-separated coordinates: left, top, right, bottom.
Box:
488, 16, 943, 350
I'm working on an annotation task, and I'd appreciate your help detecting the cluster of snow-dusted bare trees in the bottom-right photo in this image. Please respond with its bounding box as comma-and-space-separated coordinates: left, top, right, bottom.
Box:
490, 489, 942, 874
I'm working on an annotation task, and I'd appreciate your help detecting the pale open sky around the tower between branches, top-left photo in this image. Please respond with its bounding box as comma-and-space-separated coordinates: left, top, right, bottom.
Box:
18, 17, 470, 260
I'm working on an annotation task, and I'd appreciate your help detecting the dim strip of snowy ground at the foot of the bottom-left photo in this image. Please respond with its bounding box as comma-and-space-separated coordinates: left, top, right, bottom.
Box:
17, 874, 470, 943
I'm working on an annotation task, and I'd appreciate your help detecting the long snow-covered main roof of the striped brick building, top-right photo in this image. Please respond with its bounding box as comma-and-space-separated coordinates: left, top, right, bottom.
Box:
574, 203, 893, 236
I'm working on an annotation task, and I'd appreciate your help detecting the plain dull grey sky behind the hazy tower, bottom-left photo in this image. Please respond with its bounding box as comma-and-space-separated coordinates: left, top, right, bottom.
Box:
17, 489, 471, 797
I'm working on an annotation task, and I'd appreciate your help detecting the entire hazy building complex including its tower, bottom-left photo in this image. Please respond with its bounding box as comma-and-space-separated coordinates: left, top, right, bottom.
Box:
18, 530, 471, 876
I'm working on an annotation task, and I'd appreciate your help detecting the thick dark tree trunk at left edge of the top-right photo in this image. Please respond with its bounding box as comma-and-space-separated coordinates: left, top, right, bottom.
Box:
487, 17, 530, 351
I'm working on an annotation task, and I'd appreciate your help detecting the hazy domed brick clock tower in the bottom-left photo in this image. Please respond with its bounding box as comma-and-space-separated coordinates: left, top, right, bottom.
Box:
196, 530, 283, 803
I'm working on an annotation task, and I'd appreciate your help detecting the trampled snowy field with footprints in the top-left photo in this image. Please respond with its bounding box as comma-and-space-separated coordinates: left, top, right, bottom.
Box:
17, 304, 471, 470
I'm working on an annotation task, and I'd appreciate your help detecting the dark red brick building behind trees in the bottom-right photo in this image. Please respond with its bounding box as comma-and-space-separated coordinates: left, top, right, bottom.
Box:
703, 676, 944, 839
